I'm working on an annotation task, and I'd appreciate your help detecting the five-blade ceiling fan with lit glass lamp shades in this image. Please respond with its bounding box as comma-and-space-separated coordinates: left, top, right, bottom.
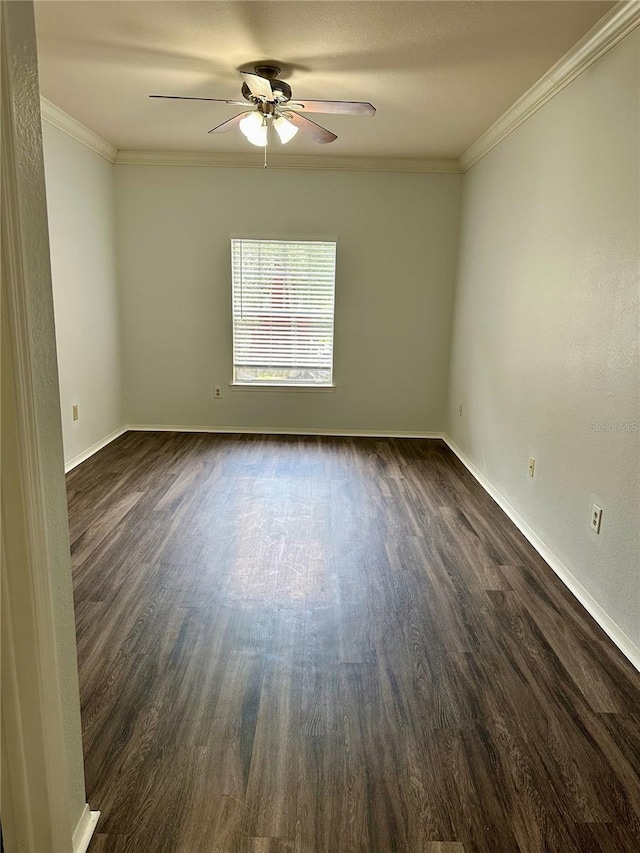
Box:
149, 65, 376, 147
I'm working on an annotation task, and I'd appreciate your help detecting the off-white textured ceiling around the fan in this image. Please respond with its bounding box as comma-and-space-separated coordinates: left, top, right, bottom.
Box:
35, 0, 614, 158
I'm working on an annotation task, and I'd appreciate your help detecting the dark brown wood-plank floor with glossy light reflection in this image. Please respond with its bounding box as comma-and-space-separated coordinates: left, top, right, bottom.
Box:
68, 433, 640, 853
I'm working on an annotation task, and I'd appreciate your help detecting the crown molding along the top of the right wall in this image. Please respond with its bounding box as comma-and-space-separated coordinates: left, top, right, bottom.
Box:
459, 0, 640, 172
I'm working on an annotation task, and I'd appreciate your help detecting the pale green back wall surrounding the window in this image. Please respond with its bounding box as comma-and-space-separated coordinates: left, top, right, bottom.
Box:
116, 166, 460, 433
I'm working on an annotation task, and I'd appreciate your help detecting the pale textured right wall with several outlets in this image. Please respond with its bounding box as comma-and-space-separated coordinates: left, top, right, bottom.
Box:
449, 31, 640, 646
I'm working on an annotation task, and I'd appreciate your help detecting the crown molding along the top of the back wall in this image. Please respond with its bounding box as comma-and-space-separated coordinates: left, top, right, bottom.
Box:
115, 151, 460, 174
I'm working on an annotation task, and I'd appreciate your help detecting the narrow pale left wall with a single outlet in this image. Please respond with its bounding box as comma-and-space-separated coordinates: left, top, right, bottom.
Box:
43, 123, 123, 463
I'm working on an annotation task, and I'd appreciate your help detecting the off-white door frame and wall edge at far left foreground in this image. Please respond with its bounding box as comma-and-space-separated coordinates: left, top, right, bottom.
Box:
0, 0, 98, 853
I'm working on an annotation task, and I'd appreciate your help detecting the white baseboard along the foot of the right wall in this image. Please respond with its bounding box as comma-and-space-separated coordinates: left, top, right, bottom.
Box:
443, 433, 640, 671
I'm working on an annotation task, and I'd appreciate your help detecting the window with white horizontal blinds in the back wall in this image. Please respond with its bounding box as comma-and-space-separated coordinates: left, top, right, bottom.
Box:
231, 240, 336, 386
